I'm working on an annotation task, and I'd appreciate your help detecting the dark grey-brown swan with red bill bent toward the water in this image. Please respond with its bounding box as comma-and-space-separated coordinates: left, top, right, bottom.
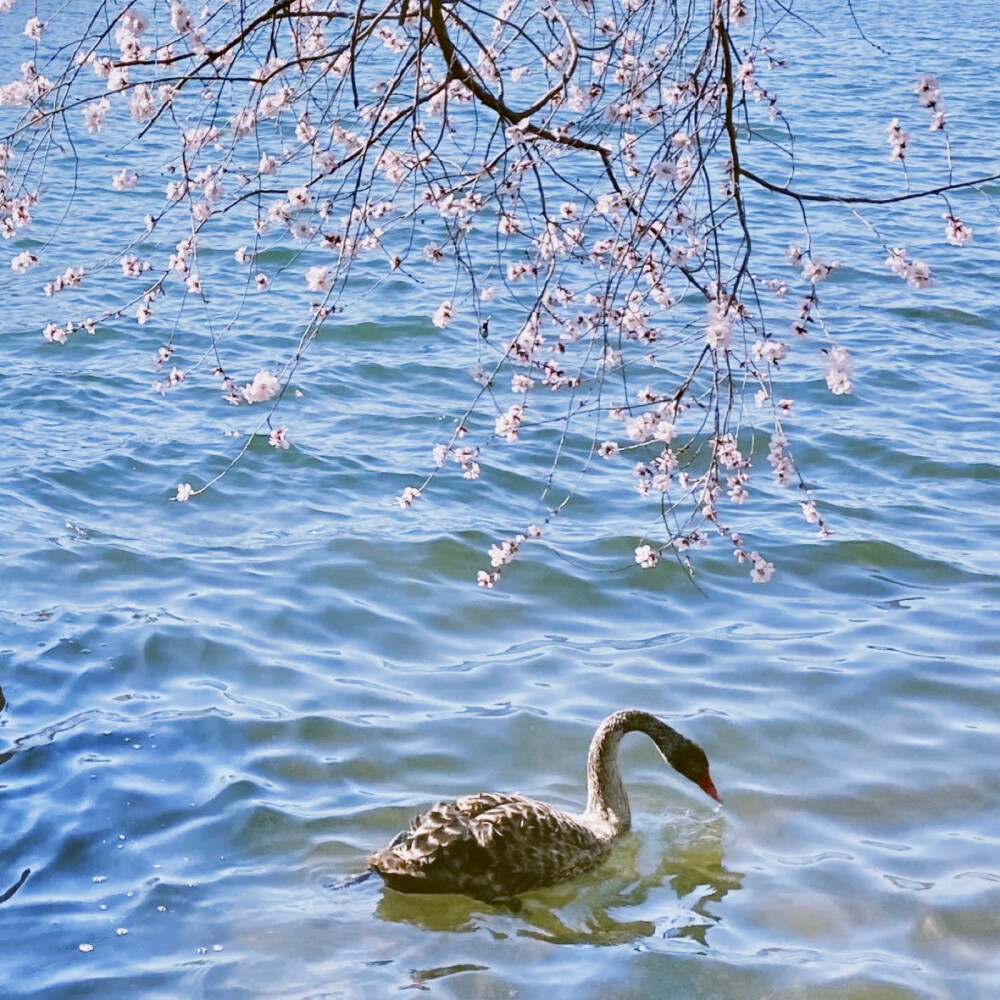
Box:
368, 709, 722, 900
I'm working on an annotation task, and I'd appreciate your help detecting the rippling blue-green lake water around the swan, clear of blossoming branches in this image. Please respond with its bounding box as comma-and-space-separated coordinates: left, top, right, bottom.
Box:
0, 2, 1000, 1000
